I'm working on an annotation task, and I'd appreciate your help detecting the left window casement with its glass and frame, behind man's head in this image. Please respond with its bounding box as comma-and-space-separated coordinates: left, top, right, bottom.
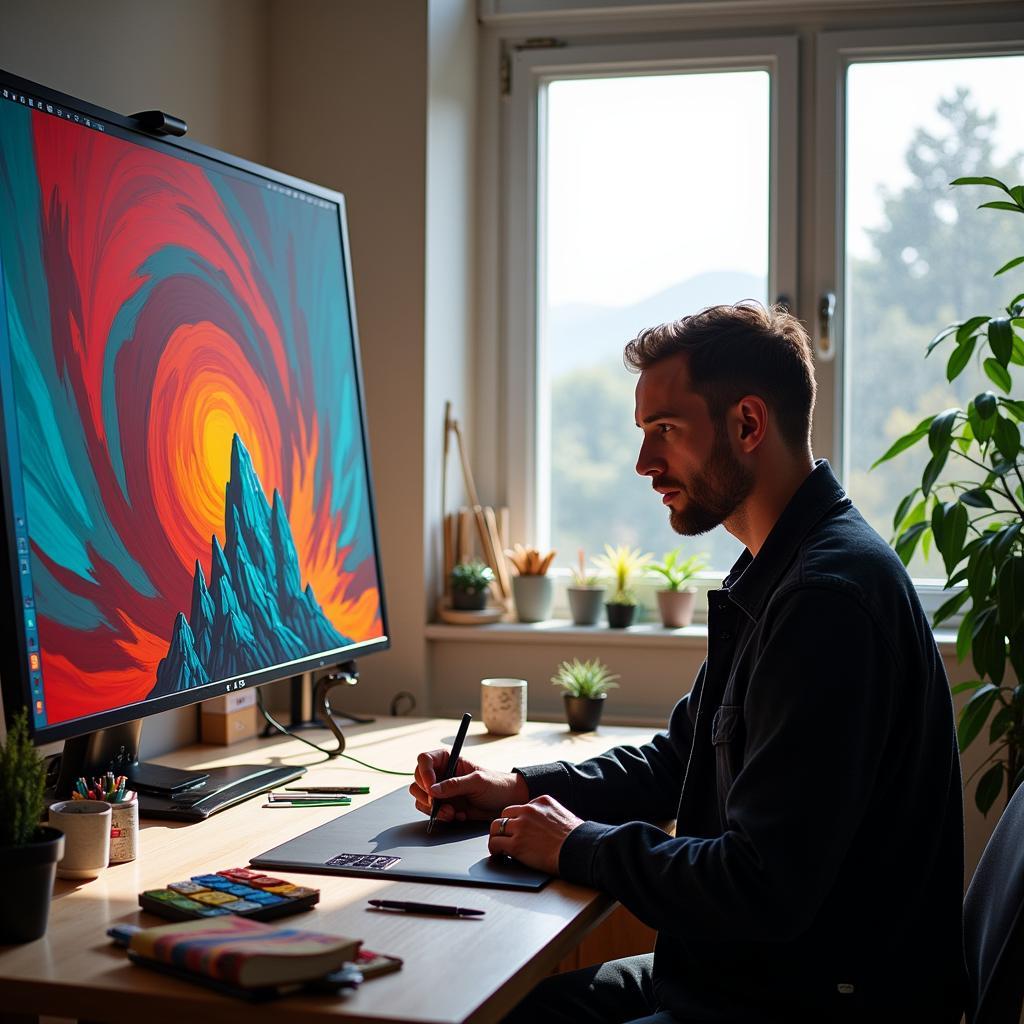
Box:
509, 40, 796, 568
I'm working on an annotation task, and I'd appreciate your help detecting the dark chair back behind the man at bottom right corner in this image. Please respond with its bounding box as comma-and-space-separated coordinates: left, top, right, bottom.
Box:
964, 785, 1024, 1024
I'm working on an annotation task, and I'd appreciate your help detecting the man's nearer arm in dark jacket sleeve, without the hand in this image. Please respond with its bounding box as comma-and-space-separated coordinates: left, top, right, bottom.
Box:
540, 589, 903, 940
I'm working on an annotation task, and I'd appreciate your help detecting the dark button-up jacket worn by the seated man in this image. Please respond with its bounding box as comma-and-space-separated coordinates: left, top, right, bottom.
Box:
518, 462, 964, 1024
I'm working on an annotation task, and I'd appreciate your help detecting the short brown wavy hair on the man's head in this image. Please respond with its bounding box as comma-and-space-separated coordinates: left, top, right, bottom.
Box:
623, 301, 816, 449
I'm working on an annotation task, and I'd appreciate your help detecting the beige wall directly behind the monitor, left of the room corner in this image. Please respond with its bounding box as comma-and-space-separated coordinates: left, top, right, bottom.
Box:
0, 0, 269, 757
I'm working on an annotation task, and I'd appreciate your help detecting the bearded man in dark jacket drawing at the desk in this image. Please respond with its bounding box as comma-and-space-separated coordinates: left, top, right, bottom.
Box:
411, 303, 964, 1024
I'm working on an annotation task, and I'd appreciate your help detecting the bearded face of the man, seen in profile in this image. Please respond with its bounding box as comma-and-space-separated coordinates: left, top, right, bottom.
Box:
636, 353, 754, 537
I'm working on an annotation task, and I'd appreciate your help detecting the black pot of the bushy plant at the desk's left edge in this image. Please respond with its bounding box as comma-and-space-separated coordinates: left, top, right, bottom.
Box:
0, 826, 63, 945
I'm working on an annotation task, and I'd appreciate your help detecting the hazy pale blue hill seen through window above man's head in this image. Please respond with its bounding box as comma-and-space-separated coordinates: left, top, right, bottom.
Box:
547, 270, 767, 377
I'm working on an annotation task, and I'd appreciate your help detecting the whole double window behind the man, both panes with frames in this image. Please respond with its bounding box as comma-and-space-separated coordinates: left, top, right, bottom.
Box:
501, 14, 1024, 593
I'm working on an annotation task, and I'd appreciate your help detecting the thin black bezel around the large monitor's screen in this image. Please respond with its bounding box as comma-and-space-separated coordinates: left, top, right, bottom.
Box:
0, 69, 391, 744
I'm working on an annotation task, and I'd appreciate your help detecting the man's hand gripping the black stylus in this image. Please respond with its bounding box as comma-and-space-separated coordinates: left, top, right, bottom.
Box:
409, 750, 529, 821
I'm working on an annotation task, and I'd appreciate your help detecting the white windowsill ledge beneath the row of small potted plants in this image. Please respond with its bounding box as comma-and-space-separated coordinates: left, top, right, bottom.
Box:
426, 618, 956, 655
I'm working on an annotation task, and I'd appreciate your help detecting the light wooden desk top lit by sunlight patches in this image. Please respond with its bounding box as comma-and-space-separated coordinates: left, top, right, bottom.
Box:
0, 718, 653, 1024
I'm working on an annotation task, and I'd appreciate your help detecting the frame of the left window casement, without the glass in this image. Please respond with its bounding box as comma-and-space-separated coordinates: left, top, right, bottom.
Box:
499, 34, 799, 546
